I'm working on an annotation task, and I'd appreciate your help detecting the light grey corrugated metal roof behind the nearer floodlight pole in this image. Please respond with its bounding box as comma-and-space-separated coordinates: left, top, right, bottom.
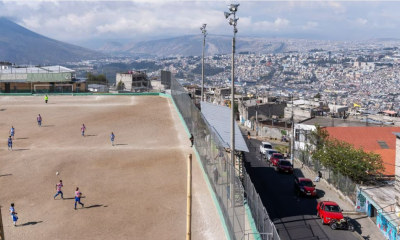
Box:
201, 102, 249, 152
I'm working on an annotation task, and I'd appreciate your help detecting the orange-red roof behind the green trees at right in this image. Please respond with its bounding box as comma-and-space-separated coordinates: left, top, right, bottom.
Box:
325, 127, 400, 175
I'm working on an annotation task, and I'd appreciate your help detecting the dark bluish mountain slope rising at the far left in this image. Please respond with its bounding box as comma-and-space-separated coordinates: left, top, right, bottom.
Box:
0, 17, 106, 65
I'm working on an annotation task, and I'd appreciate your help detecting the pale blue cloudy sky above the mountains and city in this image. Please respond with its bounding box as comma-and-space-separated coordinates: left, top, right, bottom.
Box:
0, 0, 400, 48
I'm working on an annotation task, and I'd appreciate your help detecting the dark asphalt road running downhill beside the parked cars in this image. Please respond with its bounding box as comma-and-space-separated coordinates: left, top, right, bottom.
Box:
245, 135, 360, 240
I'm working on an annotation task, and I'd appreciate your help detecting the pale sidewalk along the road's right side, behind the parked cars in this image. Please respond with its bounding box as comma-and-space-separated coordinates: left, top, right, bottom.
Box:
238, 123, 386, 240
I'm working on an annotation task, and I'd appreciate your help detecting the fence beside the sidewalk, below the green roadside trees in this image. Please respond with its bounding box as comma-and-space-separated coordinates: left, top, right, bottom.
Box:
294, 149, 357, 204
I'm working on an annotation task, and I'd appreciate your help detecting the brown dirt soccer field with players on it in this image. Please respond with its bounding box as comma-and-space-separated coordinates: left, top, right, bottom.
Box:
0, 96, 225, 240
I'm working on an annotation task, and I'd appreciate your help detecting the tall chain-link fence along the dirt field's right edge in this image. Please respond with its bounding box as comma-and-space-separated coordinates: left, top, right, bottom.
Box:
171, 78, 246, 240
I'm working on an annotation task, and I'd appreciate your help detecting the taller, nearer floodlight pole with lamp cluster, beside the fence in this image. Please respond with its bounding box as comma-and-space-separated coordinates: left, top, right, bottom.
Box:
224, 1, 240, 207
